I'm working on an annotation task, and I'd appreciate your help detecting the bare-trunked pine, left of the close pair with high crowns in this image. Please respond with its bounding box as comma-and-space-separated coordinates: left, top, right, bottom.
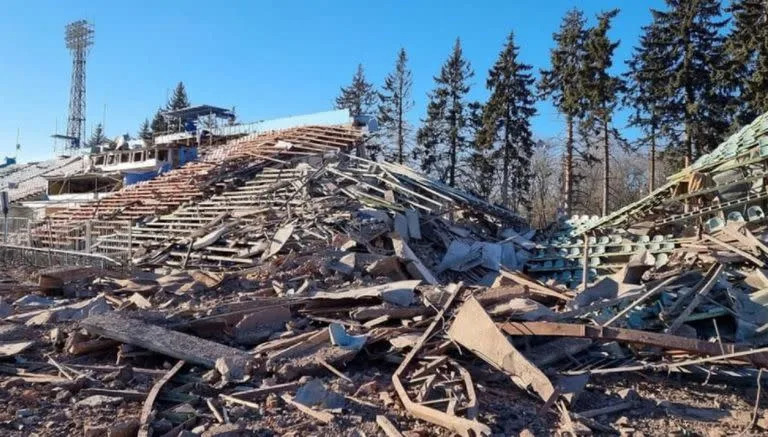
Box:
539, 9, 586, 215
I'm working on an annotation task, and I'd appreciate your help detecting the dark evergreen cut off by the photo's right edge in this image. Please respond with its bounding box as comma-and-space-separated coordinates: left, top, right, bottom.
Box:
726, 0, 768, 126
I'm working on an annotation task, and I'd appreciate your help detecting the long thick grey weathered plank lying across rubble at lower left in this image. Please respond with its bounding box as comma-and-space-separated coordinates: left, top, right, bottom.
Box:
80, 312, 250, 369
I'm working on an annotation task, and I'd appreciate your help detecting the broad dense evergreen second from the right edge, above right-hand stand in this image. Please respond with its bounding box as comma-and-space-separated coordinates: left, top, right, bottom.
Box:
651, 0, 733, 165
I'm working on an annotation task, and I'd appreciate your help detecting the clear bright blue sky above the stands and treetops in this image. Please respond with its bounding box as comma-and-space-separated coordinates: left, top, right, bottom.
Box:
0, 0, 663, 161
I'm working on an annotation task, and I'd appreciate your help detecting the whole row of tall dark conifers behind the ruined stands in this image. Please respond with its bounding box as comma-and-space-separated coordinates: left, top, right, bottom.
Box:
328, 0, 768, 221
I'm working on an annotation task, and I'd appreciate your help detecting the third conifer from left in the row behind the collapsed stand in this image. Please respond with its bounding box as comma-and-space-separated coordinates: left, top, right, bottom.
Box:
414, 38, 474, 187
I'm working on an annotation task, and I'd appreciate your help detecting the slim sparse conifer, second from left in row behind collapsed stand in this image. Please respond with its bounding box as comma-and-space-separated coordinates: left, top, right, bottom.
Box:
379, 48, 414, 164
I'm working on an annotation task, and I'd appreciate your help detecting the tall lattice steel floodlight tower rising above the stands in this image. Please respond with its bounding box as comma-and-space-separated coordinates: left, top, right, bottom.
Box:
64, 20, 93, 149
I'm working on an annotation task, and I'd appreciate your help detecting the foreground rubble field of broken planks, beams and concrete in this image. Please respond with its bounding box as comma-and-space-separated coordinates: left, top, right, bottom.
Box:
0, 203, 768, 436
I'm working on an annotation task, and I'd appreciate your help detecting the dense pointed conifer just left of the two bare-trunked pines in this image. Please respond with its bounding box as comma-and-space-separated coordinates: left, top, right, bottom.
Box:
478, 32, 536, 210
